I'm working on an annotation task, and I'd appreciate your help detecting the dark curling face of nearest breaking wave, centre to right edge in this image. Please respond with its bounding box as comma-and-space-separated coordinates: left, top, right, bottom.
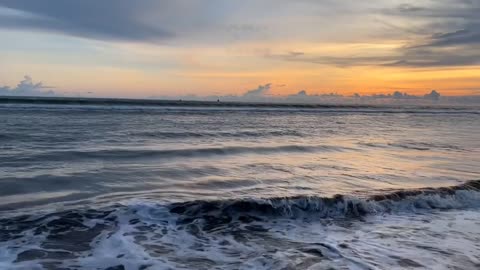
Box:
170, 180, 480, 222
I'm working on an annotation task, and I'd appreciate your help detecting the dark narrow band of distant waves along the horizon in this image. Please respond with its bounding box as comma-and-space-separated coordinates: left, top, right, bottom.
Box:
0, 96, 480, 114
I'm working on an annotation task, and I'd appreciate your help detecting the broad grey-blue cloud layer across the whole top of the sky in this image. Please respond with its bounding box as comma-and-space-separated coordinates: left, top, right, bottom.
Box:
0, 0, 480, 68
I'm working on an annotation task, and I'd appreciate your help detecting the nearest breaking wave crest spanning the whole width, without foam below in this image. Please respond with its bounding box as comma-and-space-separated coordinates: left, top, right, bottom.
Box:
0, 180, 480, 231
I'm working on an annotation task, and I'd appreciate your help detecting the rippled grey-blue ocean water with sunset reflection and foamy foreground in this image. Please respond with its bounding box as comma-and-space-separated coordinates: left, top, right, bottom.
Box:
0, 104, 480, 270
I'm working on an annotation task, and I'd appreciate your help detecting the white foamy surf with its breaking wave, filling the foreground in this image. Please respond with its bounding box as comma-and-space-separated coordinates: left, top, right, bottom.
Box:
0, 187, 480, 270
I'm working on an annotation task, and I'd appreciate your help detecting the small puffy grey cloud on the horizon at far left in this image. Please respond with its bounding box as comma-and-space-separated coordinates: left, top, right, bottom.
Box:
0, 75, 55, 96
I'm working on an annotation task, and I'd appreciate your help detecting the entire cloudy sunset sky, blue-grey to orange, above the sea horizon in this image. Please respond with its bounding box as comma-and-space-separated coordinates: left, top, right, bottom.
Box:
0, 0, 480, 98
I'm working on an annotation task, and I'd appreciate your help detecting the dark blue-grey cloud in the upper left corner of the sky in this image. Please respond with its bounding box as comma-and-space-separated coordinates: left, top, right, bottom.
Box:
0, 0, 173, 41
